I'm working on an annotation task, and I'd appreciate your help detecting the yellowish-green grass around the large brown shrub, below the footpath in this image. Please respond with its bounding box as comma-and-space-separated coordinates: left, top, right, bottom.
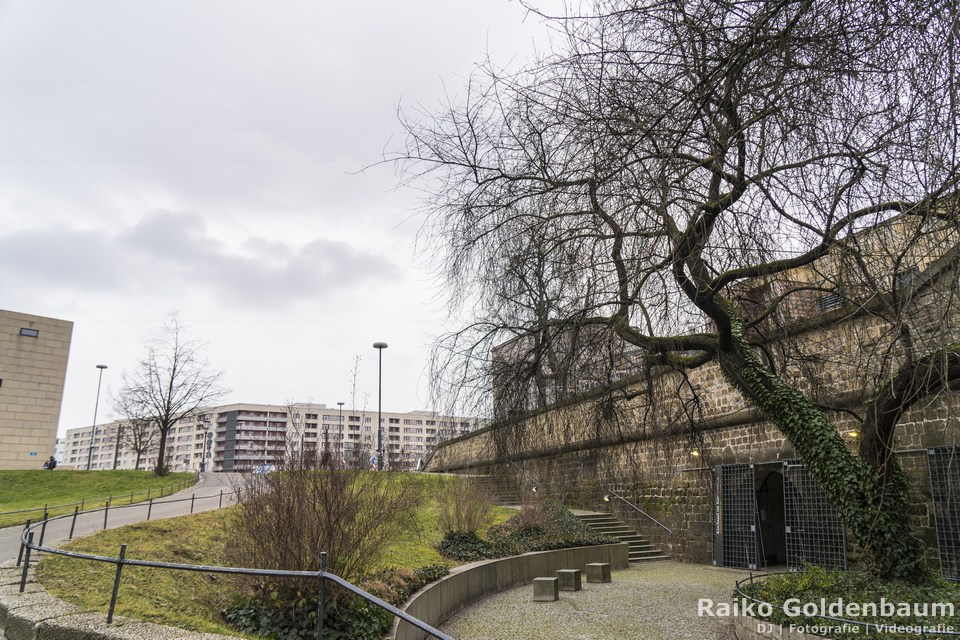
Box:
37, 474, 516, 636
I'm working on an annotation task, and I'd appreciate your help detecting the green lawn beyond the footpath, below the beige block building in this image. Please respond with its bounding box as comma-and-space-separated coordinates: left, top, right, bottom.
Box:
0, 469, 194, 527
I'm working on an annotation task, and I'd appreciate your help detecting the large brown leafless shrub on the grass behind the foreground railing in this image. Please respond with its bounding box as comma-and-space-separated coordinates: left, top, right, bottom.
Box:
228, 464, 423, 582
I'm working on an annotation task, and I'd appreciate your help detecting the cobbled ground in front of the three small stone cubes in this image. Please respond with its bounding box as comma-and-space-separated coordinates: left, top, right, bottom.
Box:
440, 562, 746, 640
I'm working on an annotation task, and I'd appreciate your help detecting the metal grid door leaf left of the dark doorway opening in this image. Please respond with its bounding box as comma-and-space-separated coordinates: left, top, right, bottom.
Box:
714, 464, 757, 569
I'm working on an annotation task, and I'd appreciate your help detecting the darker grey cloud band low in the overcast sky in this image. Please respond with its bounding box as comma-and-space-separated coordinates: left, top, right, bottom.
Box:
0, 211, 398, 308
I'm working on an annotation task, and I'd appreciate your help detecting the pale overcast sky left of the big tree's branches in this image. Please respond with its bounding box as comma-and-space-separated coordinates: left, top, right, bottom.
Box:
0, 0, 559, 433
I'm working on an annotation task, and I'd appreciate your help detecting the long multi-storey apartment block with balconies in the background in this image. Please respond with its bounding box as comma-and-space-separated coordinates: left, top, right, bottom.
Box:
62, 403, 482, 471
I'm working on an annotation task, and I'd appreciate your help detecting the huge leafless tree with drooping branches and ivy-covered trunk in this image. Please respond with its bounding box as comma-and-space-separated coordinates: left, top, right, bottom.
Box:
390, 0, 960, 579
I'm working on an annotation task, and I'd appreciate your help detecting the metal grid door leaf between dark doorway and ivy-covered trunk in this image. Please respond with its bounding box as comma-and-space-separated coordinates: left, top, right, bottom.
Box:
783, 460, 847, 570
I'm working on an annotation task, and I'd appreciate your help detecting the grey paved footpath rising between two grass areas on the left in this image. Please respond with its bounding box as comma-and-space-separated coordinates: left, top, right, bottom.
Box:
0, 473, 236, 562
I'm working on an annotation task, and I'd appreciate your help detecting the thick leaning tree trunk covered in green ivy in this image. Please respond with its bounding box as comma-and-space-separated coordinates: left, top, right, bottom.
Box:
718, 320, 930, 582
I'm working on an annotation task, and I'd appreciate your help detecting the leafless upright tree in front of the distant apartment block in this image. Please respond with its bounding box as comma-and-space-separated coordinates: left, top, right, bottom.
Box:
118, 316, 226, 476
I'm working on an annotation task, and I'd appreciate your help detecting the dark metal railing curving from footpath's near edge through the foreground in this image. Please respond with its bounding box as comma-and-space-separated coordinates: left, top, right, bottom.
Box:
17, 500, 454, 640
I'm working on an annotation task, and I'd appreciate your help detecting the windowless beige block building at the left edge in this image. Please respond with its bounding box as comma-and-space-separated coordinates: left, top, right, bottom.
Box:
0, 309, 73, 469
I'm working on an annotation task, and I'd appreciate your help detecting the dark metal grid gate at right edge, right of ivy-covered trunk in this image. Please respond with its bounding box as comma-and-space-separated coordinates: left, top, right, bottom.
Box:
927, 446, 960, 581
